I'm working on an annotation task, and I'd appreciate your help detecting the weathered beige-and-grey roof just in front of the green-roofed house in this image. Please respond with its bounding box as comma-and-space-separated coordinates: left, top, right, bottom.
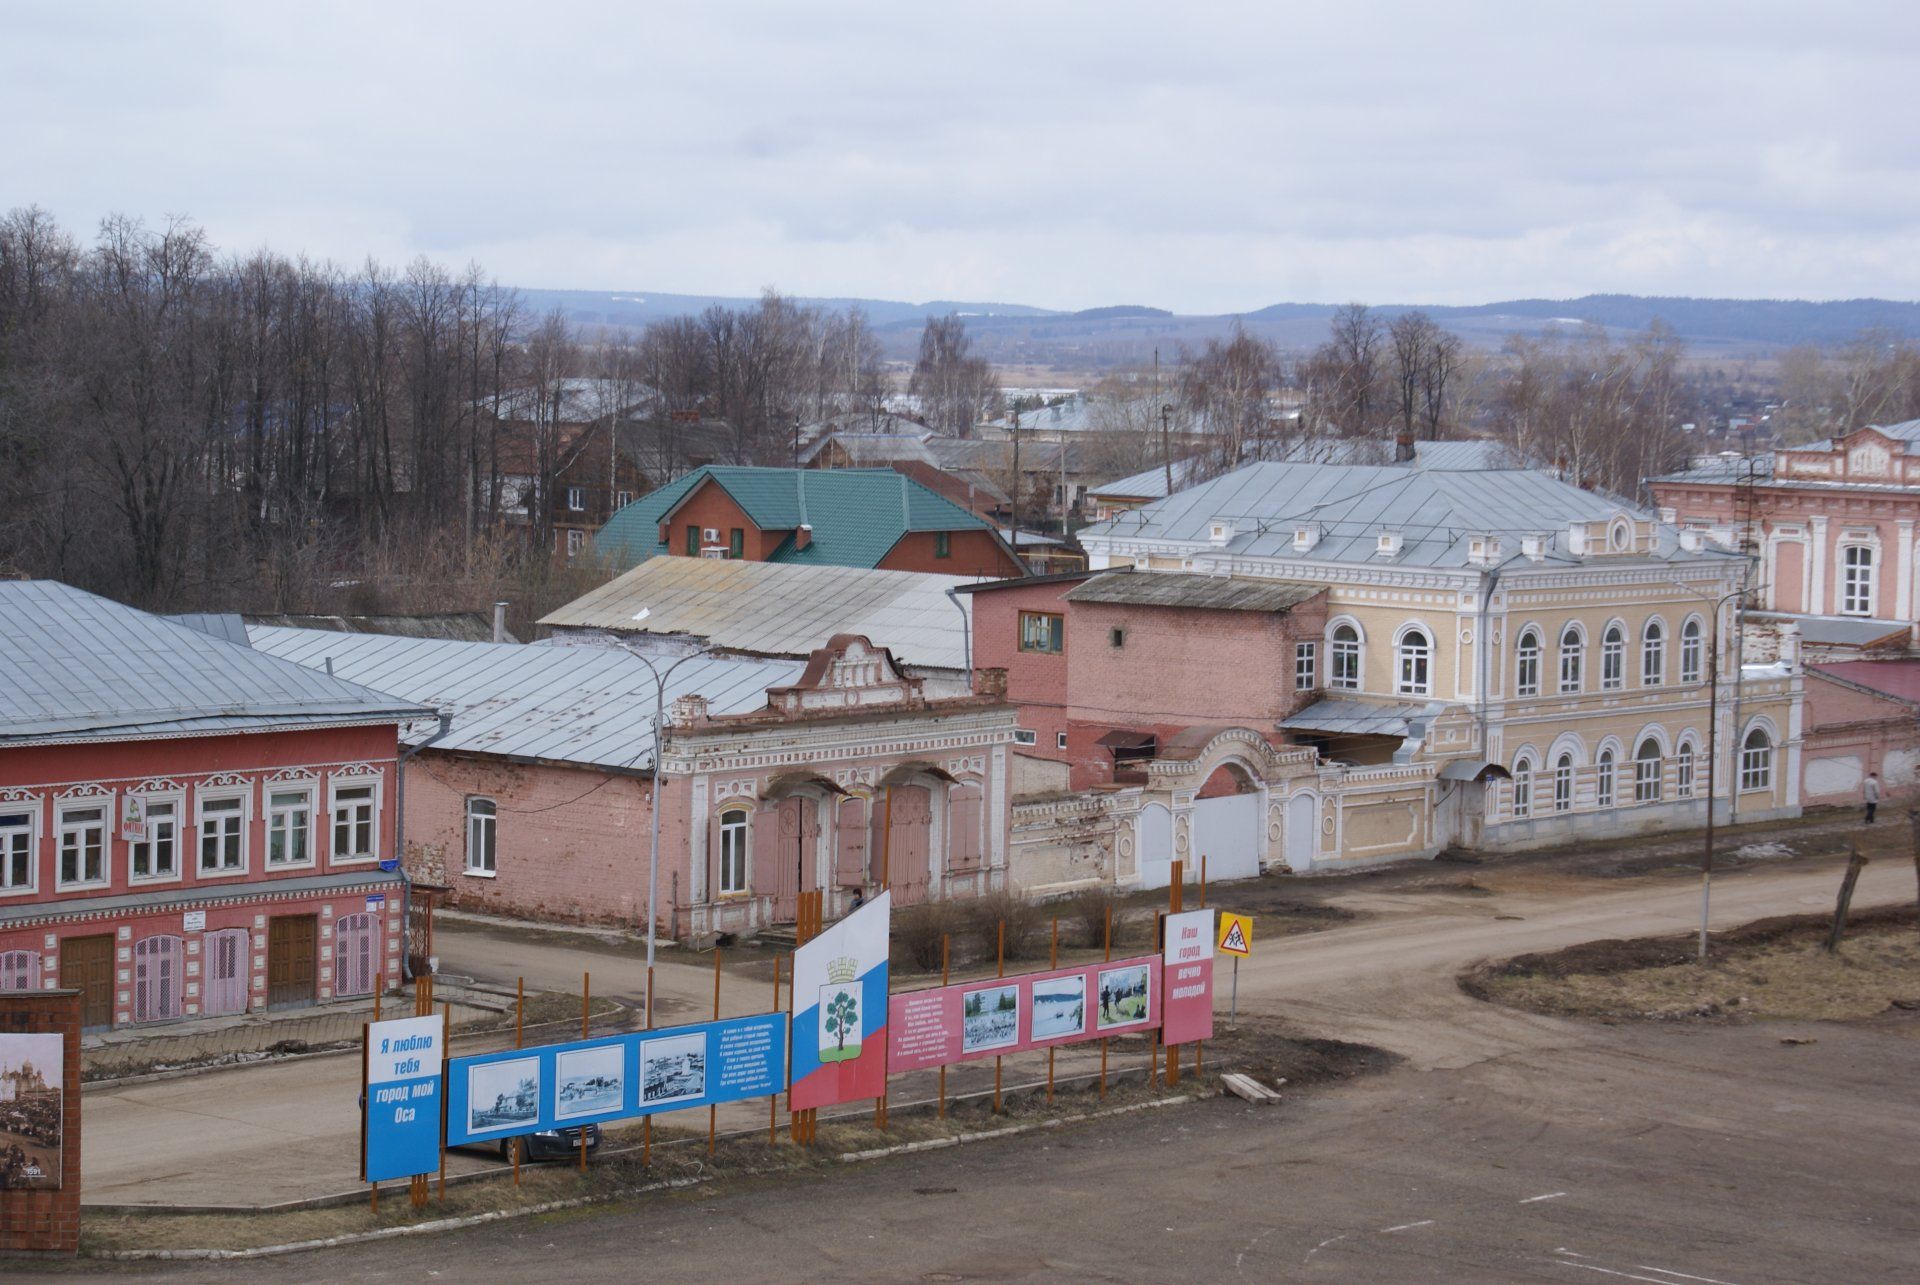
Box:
541, 557, 972, 670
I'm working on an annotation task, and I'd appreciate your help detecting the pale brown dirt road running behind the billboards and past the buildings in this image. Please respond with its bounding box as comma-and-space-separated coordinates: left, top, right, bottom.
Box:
83, 841, 1912, 1204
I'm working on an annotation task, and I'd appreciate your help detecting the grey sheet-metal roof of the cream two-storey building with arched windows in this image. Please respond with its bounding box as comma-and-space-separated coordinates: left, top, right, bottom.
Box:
1081, 463, 1728, 567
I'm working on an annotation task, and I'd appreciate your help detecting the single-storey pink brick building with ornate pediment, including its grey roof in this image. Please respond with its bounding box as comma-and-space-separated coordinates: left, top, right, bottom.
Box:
253, 630, 1014, 937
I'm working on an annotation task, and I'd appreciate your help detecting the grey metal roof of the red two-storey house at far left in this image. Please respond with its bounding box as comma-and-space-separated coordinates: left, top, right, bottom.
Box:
0, 580, 422, 745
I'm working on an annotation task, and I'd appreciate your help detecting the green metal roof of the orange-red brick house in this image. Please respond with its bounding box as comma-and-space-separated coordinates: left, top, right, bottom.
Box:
595, 465, 993, 567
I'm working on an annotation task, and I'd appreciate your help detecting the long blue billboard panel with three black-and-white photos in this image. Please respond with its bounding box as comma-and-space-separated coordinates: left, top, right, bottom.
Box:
447, 1012, 787, 1147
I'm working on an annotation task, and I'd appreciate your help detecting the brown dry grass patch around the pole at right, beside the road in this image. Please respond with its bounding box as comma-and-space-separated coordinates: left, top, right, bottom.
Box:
1463, 912, 1920, 1022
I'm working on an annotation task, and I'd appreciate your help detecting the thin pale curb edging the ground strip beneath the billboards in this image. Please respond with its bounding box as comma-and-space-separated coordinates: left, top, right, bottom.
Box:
81, 1091, 1219, 1262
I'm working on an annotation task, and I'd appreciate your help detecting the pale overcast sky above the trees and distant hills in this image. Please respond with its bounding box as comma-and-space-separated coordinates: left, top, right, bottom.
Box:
0, 0, 1920, 311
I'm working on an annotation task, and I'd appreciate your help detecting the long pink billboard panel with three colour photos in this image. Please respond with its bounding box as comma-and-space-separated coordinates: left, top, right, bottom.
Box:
887, 955, 1160, 1072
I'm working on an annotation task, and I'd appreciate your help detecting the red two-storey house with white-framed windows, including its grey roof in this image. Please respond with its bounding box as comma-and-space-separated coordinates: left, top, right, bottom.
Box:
0, 580, 432, 1028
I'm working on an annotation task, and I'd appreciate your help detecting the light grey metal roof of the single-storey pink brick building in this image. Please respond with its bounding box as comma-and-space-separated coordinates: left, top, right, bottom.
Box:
248, 622, 804, 770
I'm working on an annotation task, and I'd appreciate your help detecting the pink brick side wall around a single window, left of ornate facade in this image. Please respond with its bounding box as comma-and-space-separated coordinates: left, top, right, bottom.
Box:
407, 749, 656, 924
